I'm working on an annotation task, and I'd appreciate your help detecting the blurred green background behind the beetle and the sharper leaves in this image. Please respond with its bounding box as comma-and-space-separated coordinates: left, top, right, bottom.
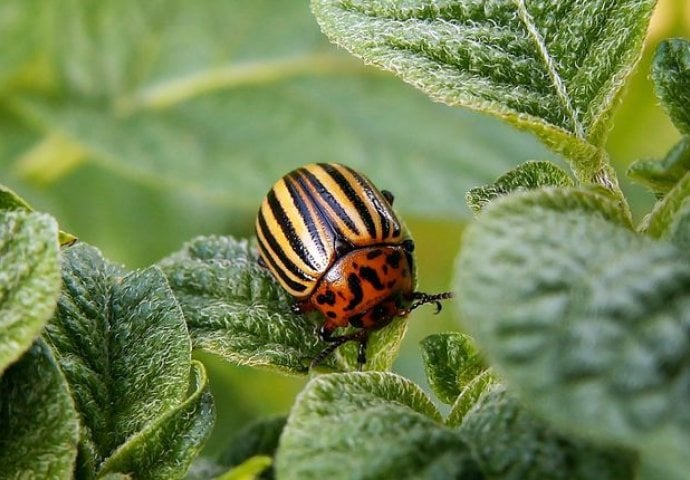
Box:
0, 0, 690, 458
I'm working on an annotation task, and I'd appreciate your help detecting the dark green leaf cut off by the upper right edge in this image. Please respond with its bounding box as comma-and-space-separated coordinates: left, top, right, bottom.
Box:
652, 38, 690, 133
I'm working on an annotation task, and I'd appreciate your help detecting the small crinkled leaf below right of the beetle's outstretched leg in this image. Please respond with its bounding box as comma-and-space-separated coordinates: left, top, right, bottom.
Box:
422, 333, 486, 404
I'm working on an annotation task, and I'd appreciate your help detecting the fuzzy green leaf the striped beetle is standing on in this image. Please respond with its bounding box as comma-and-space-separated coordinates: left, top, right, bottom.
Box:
160, 237, 405, 374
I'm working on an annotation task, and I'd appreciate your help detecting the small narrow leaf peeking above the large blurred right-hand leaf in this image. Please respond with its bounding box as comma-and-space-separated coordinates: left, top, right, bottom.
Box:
465, 161, 575, 215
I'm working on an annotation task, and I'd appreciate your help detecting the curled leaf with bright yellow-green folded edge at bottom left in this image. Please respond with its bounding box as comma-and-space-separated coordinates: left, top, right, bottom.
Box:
101, 361, 215, 479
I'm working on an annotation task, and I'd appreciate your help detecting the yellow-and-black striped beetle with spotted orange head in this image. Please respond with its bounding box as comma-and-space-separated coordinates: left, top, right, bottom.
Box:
255, 163, 452, 370
